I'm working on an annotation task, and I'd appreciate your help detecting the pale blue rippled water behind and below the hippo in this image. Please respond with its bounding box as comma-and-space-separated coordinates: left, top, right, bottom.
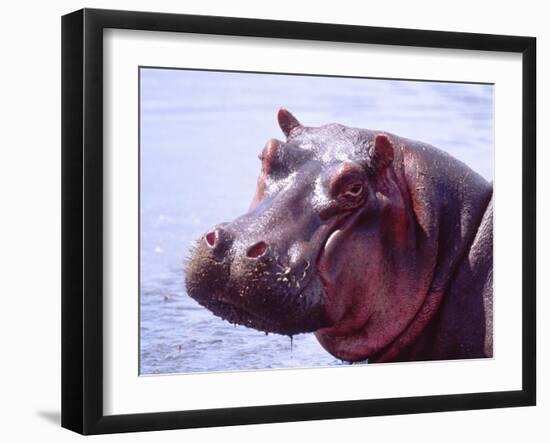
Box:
140, 69, 493, 374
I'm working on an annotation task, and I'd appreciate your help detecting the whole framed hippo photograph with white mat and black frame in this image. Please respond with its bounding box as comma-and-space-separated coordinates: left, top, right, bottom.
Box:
62, 9, 536, 434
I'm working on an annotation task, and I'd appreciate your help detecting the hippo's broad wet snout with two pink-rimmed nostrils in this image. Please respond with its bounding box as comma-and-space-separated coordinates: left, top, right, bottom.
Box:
185, 224, 332, 335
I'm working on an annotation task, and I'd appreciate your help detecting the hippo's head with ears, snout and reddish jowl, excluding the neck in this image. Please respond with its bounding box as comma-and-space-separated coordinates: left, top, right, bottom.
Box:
186, 109, 430, 360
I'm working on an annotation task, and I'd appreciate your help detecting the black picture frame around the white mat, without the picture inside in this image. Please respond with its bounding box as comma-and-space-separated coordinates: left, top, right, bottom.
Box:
62, 9, 536, 434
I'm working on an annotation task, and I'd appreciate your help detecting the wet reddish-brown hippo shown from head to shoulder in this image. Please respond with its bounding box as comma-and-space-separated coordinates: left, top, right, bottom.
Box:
185, 109, 493, 364
